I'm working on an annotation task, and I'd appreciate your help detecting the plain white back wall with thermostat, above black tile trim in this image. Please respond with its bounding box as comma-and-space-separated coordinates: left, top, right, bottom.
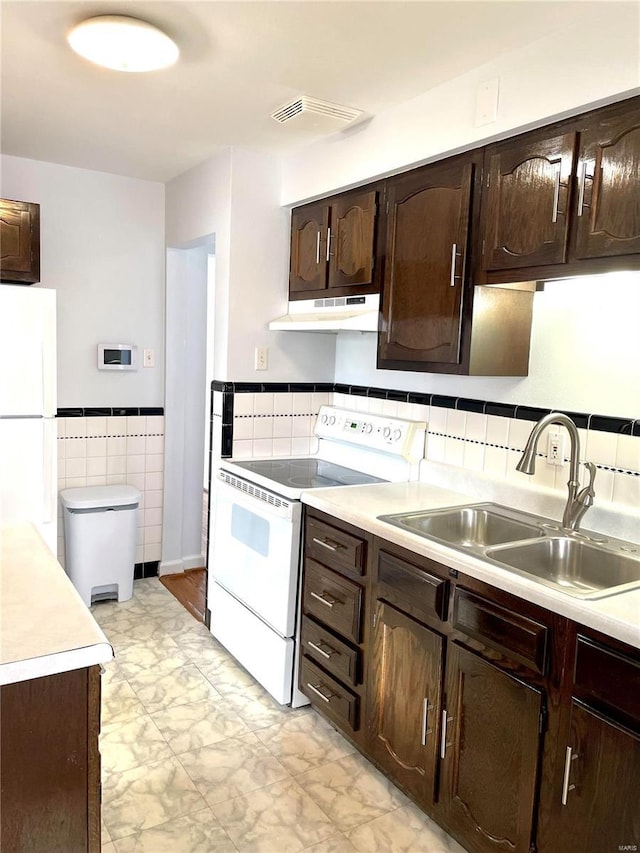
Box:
0, 155, 164, 407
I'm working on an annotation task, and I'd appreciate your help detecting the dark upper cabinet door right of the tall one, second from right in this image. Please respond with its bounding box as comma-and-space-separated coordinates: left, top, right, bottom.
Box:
483, 133, 577, 271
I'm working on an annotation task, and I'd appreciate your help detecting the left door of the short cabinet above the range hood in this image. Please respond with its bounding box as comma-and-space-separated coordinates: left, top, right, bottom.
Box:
289, 203, 329, 293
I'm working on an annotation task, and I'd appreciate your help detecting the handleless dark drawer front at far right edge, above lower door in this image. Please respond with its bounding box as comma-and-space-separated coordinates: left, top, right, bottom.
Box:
574, 635, 640, 726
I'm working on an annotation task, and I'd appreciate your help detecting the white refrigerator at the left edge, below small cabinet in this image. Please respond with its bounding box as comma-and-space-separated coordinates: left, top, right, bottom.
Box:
0, 285, 58, 555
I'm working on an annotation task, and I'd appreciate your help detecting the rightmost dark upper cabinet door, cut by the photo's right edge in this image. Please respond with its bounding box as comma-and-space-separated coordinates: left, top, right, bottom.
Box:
576, 105, 640, 258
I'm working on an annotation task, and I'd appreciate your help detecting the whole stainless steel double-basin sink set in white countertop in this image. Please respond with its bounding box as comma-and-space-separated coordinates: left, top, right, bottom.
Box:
379, 503, 640, 599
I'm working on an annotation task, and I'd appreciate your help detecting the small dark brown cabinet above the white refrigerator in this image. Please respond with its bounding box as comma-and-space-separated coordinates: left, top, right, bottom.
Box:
0, 198, 40, 284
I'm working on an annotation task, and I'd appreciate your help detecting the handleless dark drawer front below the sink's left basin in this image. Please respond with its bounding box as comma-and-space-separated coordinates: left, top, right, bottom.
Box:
378, 551, 449, 620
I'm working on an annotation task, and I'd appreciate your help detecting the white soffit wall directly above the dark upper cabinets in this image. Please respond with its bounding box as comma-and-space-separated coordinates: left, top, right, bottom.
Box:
282, 2, 640, 204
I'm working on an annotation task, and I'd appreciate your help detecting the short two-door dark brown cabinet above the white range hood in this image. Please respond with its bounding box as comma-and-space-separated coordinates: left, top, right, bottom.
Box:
289, 189, 379, 299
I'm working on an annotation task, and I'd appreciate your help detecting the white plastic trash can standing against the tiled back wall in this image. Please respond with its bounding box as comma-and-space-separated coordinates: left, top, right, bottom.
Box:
60, 486, 141, 607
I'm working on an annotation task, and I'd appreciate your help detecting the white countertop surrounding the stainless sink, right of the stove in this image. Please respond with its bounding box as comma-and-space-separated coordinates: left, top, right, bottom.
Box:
302, 482, 640, 648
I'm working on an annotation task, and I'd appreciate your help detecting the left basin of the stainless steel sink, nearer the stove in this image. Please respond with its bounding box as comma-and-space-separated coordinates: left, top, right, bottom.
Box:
380, 504, 544, 549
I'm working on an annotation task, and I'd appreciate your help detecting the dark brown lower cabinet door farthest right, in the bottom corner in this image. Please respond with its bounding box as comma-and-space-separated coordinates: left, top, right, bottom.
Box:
540, 700, 640, 853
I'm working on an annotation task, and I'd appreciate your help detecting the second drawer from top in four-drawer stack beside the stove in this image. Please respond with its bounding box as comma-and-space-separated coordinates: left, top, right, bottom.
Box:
302, 560, 362, 643
